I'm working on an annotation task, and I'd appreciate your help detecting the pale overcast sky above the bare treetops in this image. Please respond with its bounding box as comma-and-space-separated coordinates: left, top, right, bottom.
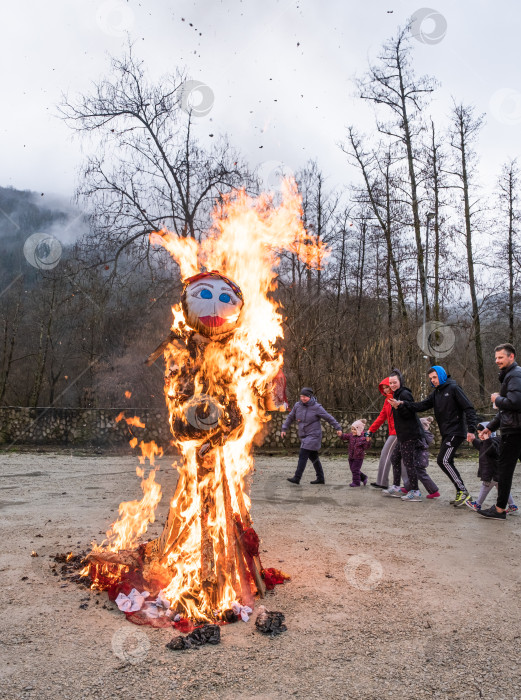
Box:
0, 0, 521, 202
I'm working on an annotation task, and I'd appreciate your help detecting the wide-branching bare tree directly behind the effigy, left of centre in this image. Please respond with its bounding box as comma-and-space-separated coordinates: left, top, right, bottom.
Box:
60, 47, 249, 262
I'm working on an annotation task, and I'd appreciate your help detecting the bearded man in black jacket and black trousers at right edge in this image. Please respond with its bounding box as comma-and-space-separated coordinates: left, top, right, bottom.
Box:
479, 343, 521, 520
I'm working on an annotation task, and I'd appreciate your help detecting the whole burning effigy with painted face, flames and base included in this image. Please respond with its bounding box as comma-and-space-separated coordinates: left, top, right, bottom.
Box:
83, 181, 326, 624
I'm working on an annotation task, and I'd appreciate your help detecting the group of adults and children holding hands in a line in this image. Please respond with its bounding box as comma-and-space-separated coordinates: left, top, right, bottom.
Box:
281, 343, 521, 520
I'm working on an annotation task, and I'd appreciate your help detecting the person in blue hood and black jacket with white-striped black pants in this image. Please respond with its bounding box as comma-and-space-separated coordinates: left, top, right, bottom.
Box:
390, 365, 477, 508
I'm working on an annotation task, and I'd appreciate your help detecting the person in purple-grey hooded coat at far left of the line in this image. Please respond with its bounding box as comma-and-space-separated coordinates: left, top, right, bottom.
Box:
280, 386, 342, 484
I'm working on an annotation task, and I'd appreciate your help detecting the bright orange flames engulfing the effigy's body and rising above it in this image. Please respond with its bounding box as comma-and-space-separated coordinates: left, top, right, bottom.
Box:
89, 180, 328, 620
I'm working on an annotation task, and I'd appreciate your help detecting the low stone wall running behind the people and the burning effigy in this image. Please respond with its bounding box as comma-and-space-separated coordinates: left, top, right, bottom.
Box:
0, 406, 456, 449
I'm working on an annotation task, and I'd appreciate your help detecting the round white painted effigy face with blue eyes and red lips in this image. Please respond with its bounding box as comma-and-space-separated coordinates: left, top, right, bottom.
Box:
182, 272, 243, 340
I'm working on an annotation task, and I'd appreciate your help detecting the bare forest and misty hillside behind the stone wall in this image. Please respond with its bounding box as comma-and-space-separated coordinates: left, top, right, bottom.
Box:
0, 27, 521, 412
